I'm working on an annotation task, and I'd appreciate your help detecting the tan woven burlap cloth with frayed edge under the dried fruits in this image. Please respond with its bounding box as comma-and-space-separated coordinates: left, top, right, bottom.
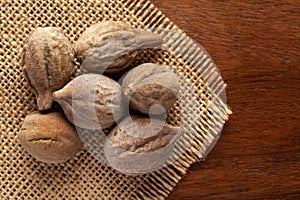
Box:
0, 0, 230, 199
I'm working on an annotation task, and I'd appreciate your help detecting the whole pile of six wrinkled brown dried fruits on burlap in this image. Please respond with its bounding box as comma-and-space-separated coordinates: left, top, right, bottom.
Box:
19, 21, 179, 173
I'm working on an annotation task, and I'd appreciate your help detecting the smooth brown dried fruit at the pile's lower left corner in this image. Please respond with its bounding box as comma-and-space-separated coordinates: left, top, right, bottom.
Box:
19, 112, 83, 163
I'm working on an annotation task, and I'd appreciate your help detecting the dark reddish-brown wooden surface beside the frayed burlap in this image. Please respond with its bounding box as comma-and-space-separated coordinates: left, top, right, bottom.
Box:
152, 0, 300, 200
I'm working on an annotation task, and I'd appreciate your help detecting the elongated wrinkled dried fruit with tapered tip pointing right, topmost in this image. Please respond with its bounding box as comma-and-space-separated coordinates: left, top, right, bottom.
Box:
75, 21, 163, 73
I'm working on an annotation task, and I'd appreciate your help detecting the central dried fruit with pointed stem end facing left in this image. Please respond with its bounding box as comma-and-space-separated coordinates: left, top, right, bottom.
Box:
53, 74, 125, 130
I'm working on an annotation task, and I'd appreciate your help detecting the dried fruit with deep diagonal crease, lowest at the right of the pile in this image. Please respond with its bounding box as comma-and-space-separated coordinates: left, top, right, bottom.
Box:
104, 116, 181, 174
